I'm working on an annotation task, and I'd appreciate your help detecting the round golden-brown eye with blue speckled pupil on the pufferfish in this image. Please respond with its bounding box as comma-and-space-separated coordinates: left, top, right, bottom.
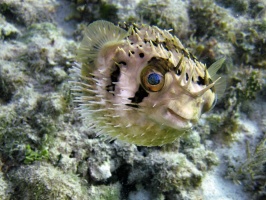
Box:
141, 68, 164, 92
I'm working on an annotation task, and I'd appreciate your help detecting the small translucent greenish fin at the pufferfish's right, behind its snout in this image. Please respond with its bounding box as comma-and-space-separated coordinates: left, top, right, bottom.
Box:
208, 57, 226, 99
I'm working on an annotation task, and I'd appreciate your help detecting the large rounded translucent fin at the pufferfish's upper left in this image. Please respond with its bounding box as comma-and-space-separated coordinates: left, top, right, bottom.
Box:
77, 20, 128, 63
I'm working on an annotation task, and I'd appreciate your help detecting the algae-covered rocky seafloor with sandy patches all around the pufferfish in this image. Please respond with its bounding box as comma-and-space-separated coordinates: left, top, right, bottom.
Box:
0, 0, 266, 200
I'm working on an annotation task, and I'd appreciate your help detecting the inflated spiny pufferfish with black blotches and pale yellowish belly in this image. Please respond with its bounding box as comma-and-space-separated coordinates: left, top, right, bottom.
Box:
73, 20, 224, 146
